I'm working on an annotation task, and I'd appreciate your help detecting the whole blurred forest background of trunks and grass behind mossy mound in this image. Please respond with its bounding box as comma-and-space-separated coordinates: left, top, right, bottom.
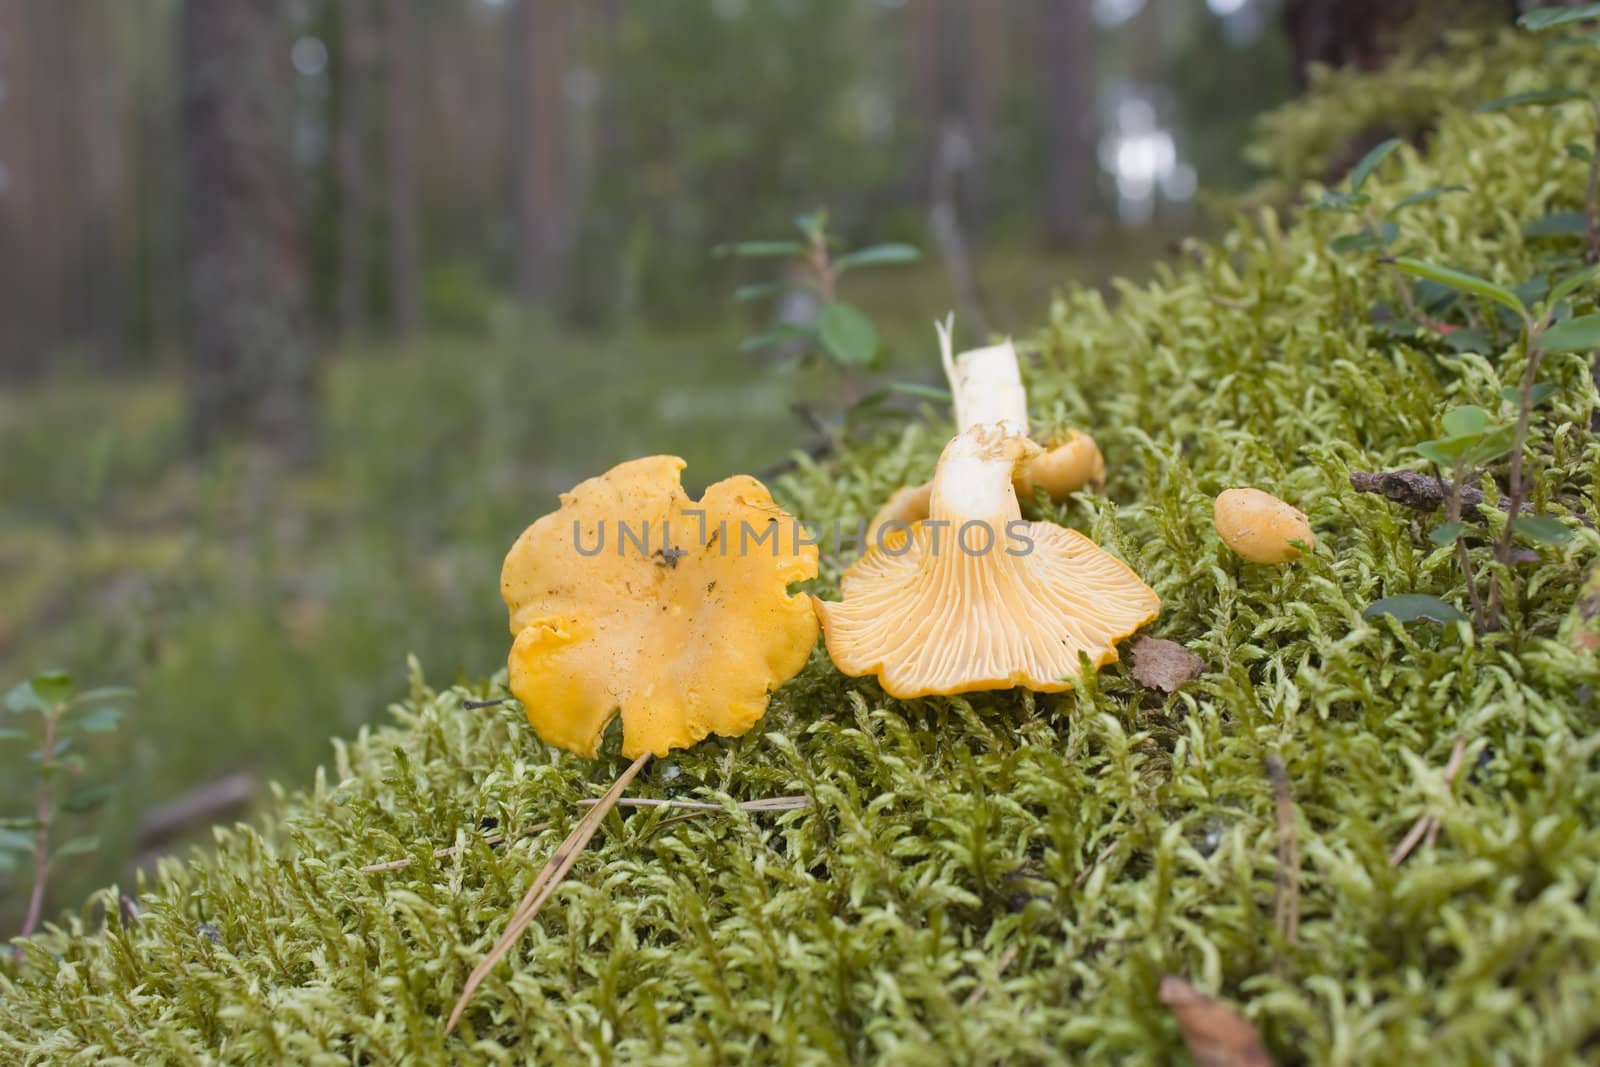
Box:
0, 0, 1504, 928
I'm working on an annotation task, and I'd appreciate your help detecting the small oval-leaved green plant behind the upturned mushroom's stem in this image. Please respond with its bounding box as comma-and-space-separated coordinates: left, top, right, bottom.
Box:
715, 208, 920, 368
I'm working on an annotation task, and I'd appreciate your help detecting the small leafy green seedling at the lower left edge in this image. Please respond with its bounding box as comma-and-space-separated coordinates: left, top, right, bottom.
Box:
0, 670, 128, 937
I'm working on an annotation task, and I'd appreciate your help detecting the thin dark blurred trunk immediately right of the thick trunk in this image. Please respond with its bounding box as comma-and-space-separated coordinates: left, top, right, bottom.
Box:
334, 0, 378, 339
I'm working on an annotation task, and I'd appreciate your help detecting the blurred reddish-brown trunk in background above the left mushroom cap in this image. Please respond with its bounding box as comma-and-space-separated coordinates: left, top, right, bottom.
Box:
512, 0, 571, 304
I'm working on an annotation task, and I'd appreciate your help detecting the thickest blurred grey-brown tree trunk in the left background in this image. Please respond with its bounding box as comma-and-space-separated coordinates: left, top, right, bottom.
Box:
178, 0, 315, 462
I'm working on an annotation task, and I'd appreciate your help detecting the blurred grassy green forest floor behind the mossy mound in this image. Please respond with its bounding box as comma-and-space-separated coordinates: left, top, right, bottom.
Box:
0, 238, 1154, 929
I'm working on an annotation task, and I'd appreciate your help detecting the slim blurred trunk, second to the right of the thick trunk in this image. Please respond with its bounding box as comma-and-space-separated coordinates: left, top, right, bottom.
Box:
382, 0, 422, 339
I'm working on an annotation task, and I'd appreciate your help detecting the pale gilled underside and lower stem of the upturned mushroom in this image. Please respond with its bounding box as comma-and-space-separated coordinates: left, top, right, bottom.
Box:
816, 427, 1162, 699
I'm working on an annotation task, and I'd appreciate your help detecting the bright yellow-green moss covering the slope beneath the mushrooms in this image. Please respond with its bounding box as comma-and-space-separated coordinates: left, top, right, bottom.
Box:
0, 29, 1600, 1064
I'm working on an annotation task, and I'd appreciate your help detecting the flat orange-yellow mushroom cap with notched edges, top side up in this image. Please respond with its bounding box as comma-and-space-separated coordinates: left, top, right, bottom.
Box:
501, 456, 818, 758
